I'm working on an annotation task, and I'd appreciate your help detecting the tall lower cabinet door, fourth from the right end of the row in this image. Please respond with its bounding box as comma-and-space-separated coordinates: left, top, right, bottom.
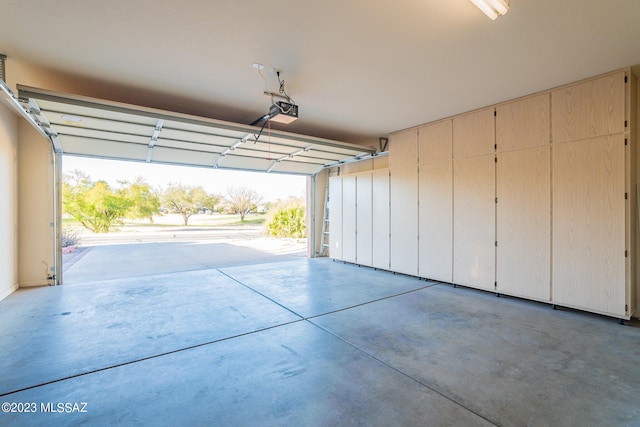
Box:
418, 160, 453, 282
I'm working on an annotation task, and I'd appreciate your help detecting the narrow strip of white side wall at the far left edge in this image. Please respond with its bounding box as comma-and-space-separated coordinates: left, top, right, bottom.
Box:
0, 102, 18, 299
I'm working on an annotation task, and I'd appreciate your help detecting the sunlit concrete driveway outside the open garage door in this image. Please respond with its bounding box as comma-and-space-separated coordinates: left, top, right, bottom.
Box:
62, 227, 307, 285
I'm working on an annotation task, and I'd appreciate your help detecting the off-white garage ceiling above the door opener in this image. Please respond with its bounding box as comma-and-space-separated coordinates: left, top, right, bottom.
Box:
0, 0, 640, 145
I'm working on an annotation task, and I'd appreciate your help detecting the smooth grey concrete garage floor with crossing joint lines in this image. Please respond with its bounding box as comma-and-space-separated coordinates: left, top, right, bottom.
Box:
0, 258, 640, 426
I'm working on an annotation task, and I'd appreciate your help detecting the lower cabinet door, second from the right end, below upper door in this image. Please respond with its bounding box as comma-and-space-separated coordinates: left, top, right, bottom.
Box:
496, 145, 551, 302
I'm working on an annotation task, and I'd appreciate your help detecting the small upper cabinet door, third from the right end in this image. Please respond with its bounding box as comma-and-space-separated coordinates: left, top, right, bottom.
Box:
453, 107, 495, 159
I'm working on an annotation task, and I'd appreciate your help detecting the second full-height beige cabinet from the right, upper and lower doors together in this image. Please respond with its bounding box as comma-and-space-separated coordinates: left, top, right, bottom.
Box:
496, 93, 551, 302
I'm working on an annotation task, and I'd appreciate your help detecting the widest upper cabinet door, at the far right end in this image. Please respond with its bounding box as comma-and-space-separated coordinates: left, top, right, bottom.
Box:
551, 72, 625, 142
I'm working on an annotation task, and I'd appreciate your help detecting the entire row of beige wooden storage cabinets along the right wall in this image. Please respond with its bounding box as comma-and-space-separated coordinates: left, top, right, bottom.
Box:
331, 69, 640, 319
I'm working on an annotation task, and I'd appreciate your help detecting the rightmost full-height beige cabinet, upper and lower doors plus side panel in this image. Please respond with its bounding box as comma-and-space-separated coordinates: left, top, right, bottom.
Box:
551, 70, 639, 319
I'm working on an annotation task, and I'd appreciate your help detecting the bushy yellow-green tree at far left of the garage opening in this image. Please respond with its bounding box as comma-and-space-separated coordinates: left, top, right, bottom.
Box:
62, 171, 133, 233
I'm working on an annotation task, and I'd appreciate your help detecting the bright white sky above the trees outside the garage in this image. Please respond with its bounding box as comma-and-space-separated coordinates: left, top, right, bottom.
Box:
62, 156, 307, 201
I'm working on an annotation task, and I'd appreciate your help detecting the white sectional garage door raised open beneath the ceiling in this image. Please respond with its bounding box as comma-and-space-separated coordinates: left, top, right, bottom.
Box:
18, 85, 374, 175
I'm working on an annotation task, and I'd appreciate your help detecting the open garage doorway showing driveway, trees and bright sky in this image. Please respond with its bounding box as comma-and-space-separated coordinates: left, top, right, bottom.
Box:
61, 156, 307, 284
